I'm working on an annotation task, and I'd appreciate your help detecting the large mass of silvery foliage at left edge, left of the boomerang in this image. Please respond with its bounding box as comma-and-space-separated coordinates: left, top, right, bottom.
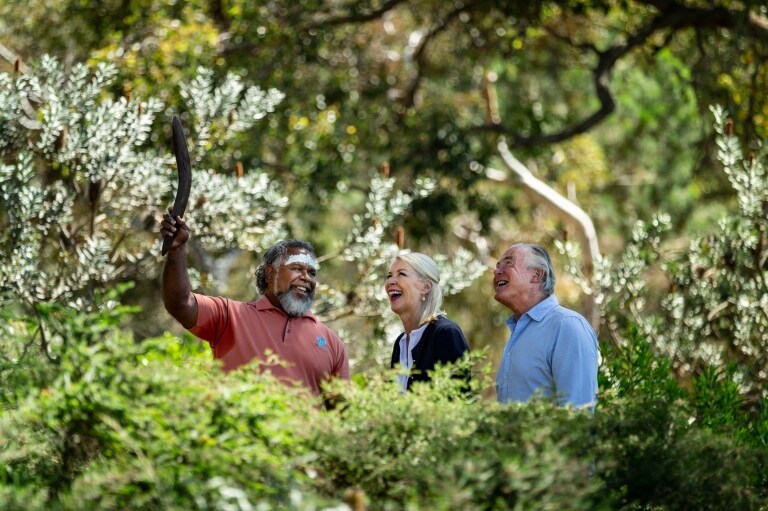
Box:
0, 57, 167, 306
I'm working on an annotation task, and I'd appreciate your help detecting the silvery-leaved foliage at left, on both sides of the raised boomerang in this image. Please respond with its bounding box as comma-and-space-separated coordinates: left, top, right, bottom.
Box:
0, 57, 286, 310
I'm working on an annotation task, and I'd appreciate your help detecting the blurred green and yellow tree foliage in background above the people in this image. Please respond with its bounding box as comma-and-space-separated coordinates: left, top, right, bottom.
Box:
6, 0, 768, 366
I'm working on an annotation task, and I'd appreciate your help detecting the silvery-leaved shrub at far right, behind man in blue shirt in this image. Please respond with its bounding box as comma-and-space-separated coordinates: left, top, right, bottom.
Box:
561, 107, 768, 397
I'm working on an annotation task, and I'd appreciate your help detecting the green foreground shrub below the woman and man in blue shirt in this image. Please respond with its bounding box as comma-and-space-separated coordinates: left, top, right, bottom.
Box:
311, 364, 599, 509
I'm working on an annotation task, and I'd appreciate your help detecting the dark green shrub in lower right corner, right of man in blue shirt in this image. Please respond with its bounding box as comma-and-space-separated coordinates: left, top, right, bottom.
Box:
595, 322, 768, 510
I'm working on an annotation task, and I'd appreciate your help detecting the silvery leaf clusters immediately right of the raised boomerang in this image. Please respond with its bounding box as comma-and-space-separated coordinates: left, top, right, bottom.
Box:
181, 68, 288, 254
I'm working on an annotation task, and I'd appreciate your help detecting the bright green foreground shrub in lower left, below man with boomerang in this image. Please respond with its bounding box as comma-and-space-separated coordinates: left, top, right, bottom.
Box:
0, 322, 340, 509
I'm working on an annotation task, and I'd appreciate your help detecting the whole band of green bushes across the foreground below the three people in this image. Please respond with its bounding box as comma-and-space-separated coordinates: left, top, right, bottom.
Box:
0, 310, 768, 510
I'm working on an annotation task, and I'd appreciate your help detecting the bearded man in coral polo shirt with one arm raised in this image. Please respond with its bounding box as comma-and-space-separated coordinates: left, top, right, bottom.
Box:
160, 213, 349, 394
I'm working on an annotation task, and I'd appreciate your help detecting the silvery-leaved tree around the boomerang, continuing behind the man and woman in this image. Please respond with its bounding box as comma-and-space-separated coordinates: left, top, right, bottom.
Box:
0, 58, 481, 368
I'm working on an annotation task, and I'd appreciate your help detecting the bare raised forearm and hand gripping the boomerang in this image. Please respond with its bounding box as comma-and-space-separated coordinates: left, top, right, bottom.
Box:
160, 208, 197, 328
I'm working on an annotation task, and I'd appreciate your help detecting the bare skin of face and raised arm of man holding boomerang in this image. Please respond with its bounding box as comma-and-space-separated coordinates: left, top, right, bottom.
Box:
160, 213, 317, 329
